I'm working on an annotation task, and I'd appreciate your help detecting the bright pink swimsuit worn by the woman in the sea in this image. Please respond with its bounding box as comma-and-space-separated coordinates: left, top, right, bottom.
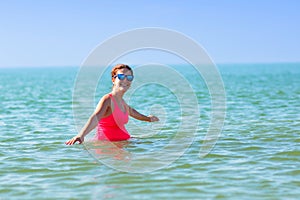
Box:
96, 94, 130, 141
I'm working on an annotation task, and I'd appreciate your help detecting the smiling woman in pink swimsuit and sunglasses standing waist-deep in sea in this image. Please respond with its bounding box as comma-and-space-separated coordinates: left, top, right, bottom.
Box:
66, 64, 159, 145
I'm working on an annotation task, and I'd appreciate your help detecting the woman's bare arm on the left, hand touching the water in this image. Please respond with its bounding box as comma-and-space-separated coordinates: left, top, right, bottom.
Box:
66, 95, 110, 145
